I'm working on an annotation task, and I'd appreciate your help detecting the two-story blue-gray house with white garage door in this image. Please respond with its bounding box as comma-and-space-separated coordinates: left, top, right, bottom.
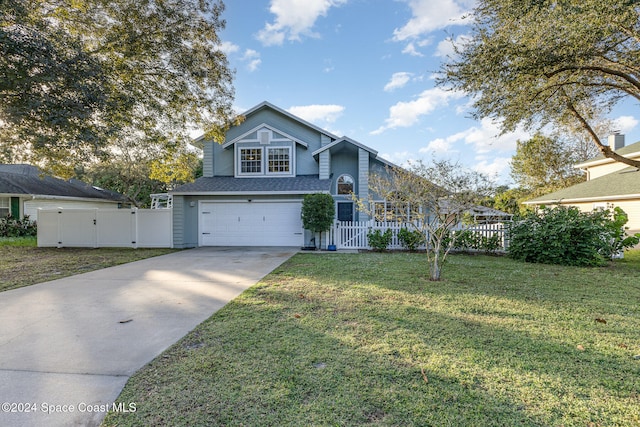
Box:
170, 102, 393, 248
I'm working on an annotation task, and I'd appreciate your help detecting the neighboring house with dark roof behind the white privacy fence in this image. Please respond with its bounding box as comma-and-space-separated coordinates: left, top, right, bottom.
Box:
0, 164, 123, 220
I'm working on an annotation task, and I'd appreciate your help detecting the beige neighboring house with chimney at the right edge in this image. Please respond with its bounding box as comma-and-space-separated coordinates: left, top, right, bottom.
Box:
525, 135, 640, 233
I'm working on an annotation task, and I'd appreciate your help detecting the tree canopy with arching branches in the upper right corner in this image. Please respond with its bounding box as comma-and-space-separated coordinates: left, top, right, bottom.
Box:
438, 0, 640, 167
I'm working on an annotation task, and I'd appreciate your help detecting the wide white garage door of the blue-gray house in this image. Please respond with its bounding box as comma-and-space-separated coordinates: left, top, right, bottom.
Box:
199, 201, 303, 246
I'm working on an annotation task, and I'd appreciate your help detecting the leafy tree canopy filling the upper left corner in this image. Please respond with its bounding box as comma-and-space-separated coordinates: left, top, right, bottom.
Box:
0, 0, 233, 176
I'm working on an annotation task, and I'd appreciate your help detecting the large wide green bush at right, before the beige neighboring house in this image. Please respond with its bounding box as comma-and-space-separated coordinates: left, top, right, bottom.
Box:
508, 206, 638, 266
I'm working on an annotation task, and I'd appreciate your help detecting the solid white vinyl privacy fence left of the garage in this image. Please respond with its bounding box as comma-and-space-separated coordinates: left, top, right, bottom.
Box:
38, 208, 173, 248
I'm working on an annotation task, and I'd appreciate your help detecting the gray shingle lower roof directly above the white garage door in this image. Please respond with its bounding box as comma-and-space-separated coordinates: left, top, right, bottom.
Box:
170, 175, 331, 195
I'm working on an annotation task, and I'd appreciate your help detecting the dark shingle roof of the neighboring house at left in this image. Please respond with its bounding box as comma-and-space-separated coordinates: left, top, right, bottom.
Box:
0, 164, 123, 201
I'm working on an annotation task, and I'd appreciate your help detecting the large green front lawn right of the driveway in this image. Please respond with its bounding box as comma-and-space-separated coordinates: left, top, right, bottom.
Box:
104, 253, 640, 426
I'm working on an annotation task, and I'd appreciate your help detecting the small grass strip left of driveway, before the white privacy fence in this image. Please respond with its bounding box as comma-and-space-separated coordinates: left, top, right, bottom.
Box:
0, 237, 175, 291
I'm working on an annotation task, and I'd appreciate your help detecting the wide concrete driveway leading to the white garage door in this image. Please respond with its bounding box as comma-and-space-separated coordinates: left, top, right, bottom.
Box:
0, 248, 297, 426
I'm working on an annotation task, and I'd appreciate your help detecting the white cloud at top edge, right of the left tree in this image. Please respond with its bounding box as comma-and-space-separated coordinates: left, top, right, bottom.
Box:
256, 0, 347, 46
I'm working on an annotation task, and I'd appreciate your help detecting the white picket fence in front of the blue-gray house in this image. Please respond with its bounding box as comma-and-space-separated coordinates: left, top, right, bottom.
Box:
327, 221, 508, 250
